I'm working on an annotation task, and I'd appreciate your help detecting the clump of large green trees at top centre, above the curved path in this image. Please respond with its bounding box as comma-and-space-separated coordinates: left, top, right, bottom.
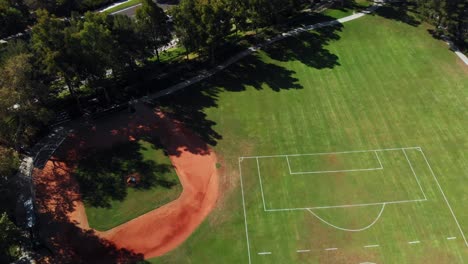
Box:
171, 0, 308, 61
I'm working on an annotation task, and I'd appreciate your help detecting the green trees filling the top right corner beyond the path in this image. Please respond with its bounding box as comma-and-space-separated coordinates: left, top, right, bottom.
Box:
408, 0, 468, 49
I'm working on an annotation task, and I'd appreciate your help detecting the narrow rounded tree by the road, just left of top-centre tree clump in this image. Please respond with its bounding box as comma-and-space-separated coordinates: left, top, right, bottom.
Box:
136, 0, 171, 61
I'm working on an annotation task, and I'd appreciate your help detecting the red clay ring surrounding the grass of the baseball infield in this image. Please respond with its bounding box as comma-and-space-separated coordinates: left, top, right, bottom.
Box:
35, 102, 219, 263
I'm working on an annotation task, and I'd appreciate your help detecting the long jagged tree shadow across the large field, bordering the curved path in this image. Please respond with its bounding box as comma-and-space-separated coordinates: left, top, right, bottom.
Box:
154, 21, 342, 146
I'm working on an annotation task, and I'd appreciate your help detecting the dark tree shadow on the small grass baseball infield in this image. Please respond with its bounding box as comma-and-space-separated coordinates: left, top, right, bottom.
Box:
73, 141, 177, 208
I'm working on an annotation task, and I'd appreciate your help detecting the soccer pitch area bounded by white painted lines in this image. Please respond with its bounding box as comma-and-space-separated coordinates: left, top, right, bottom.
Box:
239, 147, 465, 263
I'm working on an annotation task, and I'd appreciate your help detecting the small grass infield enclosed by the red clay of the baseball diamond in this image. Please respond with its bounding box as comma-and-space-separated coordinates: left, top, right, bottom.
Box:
78, 141, 182, 231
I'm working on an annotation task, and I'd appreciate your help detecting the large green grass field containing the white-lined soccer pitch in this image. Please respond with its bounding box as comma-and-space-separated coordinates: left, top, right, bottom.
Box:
150, 4, 468, 263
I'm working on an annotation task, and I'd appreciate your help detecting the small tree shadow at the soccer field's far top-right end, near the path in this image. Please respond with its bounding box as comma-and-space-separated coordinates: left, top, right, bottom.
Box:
372, 3, 421, 27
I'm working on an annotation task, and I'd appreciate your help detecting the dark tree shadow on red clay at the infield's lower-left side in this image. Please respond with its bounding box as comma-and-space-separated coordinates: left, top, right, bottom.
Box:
33, 158, 148, 263
